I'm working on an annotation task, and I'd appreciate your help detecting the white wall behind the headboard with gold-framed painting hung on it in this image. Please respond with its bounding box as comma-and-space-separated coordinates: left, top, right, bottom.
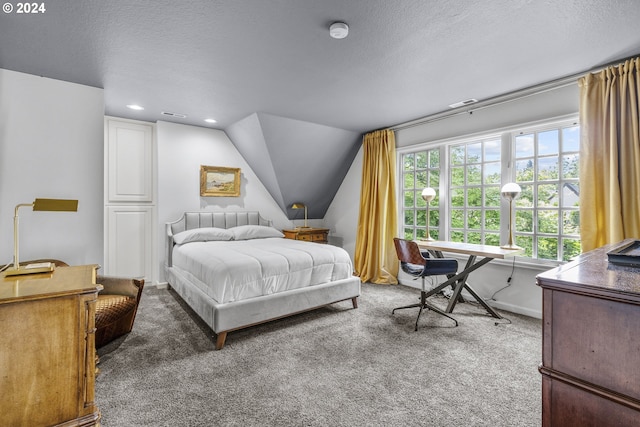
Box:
156, 122, 292, 282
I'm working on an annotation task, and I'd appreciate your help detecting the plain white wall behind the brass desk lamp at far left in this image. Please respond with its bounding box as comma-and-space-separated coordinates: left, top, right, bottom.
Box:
0, 69, 104, 264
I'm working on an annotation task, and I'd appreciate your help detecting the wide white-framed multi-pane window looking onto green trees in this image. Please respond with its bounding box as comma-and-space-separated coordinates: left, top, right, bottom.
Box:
400, 120, 580, 261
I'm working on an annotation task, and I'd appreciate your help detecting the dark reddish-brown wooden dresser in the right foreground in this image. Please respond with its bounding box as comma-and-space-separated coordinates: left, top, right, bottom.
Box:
537, 240, 640, 427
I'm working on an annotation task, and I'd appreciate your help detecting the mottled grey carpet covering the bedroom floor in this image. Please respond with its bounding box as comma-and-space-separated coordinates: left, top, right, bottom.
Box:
96, 284, 541, 427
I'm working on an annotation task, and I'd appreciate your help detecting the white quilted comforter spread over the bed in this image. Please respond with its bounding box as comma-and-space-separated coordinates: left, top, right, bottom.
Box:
173, 238, 353, 303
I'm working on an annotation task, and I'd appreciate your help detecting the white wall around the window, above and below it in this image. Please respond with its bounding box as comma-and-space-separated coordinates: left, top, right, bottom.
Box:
325, 84, 579, 318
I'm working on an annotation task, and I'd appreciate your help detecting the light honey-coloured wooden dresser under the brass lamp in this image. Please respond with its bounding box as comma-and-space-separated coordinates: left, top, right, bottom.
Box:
0, 265, 102, 426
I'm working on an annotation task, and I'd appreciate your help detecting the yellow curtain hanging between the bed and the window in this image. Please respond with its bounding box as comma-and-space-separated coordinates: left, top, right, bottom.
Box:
354, 129, 398, 284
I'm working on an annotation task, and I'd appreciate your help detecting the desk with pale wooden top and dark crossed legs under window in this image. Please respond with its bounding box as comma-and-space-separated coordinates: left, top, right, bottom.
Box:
416, 240, 524, 319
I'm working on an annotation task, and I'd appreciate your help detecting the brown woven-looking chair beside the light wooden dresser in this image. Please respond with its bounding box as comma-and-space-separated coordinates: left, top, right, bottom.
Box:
96, 275, 144, 348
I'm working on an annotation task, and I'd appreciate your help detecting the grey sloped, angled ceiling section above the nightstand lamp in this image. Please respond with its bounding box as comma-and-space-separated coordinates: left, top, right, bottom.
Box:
225, 113, 362, 219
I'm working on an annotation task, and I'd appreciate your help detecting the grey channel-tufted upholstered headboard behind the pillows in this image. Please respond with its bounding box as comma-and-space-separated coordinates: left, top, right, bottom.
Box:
165, 211, 273, 267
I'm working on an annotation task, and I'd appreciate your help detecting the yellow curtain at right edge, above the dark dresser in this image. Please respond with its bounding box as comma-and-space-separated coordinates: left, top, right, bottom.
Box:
578, 58, 640, 251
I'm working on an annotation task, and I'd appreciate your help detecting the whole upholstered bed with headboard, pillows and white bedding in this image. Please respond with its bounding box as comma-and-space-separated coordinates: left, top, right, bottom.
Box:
165, 211, 360, 350
